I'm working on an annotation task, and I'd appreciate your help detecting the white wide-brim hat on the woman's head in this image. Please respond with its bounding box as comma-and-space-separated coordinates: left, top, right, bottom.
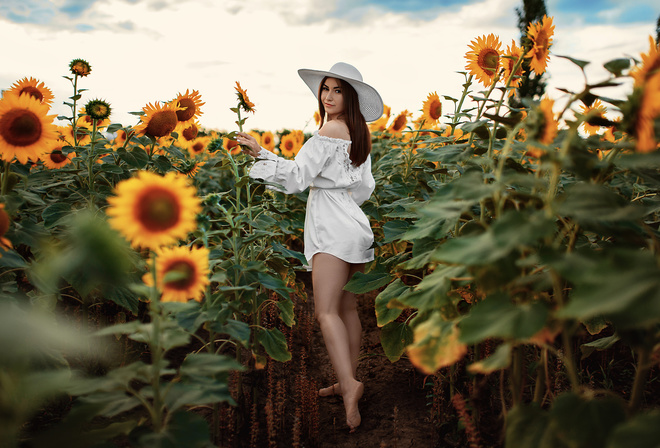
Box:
298, 62, 383, 121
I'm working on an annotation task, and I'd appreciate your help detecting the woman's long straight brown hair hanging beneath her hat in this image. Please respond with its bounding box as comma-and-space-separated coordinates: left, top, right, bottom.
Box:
318, 76, 371, 166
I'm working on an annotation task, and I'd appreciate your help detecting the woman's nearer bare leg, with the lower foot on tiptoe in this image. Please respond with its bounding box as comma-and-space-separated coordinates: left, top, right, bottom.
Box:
312, 253, 364, 431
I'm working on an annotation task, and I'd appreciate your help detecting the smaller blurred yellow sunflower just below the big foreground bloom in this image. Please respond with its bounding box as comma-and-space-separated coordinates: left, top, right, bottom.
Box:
144, 246, 210, 302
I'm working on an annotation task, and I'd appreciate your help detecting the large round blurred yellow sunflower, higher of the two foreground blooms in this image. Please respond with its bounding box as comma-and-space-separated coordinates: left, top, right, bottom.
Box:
107, 171, 202, 249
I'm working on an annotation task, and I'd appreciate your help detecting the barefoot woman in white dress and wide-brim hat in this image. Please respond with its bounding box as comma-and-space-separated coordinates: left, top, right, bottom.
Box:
236, 62, 383, 432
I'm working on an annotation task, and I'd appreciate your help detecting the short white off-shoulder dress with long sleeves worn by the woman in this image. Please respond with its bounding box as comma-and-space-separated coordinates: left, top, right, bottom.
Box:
250, 131, 376, 269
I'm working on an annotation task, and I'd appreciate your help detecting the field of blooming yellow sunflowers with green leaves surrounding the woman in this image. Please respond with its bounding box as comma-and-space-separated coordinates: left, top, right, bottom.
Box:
0, 12, 660, 448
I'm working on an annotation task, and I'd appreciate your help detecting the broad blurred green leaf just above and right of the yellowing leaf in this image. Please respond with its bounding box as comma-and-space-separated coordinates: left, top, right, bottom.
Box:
459, 294, 549, 344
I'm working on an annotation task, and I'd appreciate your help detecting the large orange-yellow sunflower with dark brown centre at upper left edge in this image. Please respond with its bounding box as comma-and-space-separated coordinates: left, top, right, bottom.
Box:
0, 95, 57, 163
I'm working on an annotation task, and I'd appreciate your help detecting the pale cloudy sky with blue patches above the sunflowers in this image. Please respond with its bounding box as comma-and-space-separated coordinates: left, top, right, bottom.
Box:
0, 0, 660, 132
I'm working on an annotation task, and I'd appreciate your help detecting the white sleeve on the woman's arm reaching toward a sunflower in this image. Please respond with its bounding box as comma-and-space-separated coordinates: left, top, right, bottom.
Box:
250, 135, 332, 194
